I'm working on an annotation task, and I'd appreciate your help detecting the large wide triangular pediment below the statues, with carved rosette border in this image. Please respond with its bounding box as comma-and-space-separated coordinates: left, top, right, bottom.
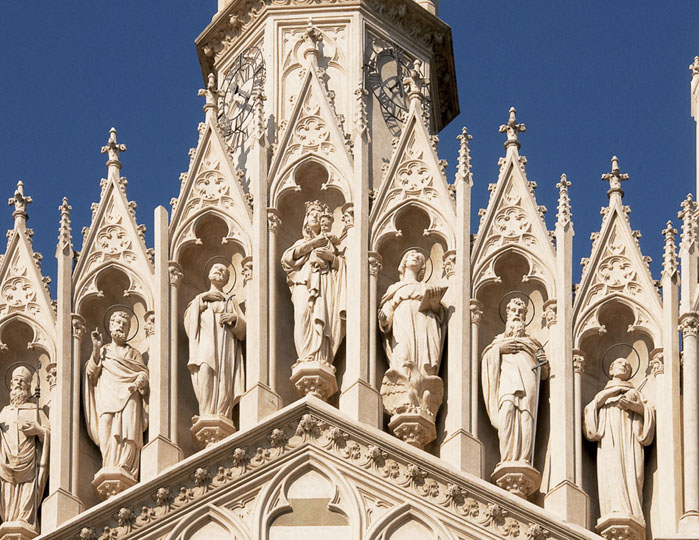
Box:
45, 396, 599, 540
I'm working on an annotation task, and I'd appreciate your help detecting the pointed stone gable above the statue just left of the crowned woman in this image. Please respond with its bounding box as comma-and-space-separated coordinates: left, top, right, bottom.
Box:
170, 117, 252, 260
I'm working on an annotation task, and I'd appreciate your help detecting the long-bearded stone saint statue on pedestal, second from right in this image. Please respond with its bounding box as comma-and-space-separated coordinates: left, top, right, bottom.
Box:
481, 298, 548, 498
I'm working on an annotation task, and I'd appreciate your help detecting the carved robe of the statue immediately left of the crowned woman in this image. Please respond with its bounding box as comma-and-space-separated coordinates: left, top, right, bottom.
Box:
184, 291, 245, 418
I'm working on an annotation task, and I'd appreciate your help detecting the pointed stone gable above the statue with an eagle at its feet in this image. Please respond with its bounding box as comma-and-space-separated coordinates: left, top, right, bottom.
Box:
370, 101, 456, 249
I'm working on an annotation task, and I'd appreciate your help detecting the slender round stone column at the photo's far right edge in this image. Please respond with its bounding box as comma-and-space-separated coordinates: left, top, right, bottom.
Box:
680, 312, 699, 522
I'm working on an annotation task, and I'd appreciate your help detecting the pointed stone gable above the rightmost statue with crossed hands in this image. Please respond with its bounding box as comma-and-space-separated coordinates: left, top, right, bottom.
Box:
573, 200, 662, 339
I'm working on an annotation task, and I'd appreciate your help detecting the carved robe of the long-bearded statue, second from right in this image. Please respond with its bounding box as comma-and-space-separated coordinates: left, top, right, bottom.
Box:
481, 334, 541, 463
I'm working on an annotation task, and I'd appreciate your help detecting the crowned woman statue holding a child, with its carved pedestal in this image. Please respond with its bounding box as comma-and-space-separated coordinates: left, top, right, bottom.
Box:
282, 201, 347, 399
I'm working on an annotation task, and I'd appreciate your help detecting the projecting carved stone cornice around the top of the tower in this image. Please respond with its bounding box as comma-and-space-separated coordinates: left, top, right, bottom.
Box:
195, 0, 459, 131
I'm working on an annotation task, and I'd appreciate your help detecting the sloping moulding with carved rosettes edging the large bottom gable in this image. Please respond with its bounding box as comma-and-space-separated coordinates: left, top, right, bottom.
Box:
60, 398, 597, 540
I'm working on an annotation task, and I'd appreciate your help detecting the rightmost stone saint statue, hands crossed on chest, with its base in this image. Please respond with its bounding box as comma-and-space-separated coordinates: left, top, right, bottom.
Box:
584, 358, 655, 539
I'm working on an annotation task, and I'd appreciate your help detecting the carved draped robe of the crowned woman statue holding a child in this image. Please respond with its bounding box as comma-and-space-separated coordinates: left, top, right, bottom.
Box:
282, 238, 347, 364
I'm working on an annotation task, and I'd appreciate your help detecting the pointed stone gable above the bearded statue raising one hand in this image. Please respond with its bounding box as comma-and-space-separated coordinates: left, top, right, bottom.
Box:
73, 177, 153, 308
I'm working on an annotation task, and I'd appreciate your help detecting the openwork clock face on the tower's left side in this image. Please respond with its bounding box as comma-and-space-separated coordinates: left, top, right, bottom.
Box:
218, 47, 265, 144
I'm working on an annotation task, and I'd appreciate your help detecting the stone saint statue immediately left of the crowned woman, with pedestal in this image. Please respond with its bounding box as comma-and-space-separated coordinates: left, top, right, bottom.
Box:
184, 263, 245, 446
